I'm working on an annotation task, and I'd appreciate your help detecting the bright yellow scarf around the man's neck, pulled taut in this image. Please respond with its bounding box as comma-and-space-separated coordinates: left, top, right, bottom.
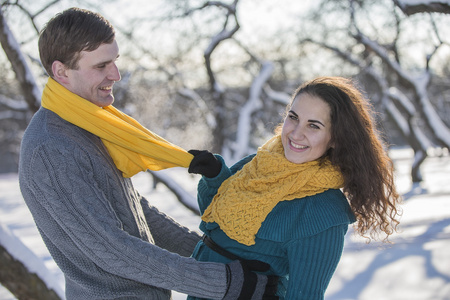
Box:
42, 78, 193, 177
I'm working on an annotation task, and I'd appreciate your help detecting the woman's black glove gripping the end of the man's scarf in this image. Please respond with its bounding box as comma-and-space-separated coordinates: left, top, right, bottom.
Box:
188, 150, 222, 178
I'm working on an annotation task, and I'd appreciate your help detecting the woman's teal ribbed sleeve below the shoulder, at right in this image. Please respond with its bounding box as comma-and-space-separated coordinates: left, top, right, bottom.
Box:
286, 225, 348, 300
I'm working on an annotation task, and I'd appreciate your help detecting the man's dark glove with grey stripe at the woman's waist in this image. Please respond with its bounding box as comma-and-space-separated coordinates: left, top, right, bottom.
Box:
223, 260, 279, 300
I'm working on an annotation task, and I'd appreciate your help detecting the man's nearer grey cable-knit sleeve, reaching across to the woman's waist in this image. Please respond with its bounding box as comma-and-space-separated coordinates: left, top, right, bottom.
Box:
21, 144, 227, 299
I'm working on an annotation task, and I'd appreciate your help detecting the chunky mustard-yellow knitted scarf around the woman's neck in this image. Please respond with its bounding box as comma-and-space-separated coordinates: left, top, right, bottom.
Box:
202, 136, 344, 246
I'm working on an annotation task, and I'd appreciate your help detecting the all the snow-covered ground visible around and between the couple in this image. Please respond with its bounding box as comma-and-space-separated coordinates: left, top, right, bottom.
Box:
0, 149, 450, 300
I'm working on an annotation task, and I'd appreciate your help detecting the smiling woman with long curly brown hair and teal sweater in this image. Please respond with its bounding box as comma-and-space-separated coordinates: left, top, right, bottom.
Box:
189, 77, 399, 300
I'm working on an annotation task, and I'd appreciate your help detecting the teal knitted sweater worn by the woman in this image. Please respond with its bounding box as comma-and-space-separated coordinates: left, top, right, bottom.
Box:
188, 155, 355, 300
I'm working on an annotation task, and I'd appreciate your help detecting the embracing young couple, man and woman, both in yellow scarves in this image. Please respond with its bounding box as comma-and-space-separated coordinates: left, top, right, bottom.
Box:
19, 8, 399, 300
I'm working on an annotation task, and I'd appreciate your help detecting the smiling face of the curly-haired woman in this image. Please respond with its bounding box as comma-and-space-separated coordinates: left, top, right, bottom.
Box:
281, 93, 331, 164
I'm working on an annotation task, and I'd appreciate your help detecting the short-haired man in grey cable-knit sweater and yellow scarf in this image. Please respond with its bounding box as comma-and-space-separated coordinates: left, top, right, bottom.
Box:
19, 8, 275, 300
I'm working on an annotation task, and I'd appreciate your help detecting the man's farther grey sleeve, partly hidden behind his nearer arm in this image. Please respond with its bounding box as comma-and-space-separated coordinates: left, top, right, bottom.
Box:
141, 197, 201, 257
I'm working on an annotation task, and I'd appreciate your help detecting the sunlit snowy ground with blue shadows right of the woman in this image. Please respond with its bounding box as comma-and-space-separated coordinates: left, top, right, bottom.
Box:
326, 150, 450, 300
